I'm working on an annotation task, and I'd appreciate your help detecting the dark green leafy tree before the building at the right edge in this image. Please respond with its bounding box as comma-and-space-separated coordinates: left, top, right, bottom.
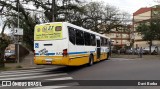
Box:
136, 19, 160, 53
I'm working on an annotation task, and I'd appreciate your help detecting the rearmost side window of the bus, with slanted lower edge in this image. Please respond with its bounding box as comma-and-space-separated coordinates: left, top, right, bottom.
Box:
68, 27, 76, 45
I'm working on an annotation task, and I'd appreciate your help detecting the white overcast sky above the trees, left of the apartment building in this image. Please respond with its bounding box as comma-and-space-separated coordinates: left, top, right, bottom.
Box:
91, 0, 157, 14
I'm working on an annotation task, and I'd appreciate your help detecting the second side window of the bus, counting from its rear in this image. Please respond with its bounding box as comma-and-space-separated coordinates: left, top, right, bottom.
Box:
76, 29, 84, 45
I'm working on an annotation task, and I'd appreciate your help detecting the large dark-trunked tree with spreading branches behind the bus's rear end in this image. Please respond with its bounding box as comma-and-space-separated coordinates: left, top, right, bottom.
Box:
0, 0, 82, 50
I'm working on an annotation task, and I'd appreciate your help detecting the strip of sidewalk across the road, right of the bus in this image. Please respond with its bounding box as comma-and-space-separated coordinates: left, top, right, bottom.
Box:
112, 54, 160, 60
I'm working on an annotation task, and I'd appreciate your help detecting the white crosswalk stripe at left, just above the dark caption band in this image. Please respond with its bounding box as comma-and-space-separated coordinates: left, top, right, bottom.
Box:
0, 73, 67, 80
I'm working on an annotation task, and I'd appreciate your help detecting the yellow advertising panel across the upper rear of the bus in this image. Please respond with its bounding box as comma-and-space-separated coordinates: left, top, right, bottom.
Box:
34, 23, 63, 40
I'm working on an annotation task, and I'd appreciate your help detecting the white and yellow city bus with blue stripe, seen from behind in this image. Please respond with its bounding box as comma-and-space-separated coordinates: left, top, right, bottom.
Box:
34, 22, 111, 66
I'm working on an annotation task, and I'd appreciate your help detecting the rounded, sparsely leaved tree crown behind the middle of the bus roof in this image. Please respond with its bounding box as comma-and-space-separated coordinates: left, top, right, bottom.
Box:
82, 2, 129, 33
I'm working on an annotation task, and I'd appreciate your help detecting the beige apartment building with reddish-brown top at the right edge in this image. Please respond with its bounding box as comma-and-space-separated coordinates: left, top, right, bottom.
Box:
132, 5, 160, 48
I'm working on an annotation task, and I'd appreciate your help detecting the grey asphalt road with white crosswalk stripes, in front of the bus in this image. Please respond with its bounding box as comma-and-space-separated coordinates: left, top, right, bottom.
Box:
0, 58, 160, 89
